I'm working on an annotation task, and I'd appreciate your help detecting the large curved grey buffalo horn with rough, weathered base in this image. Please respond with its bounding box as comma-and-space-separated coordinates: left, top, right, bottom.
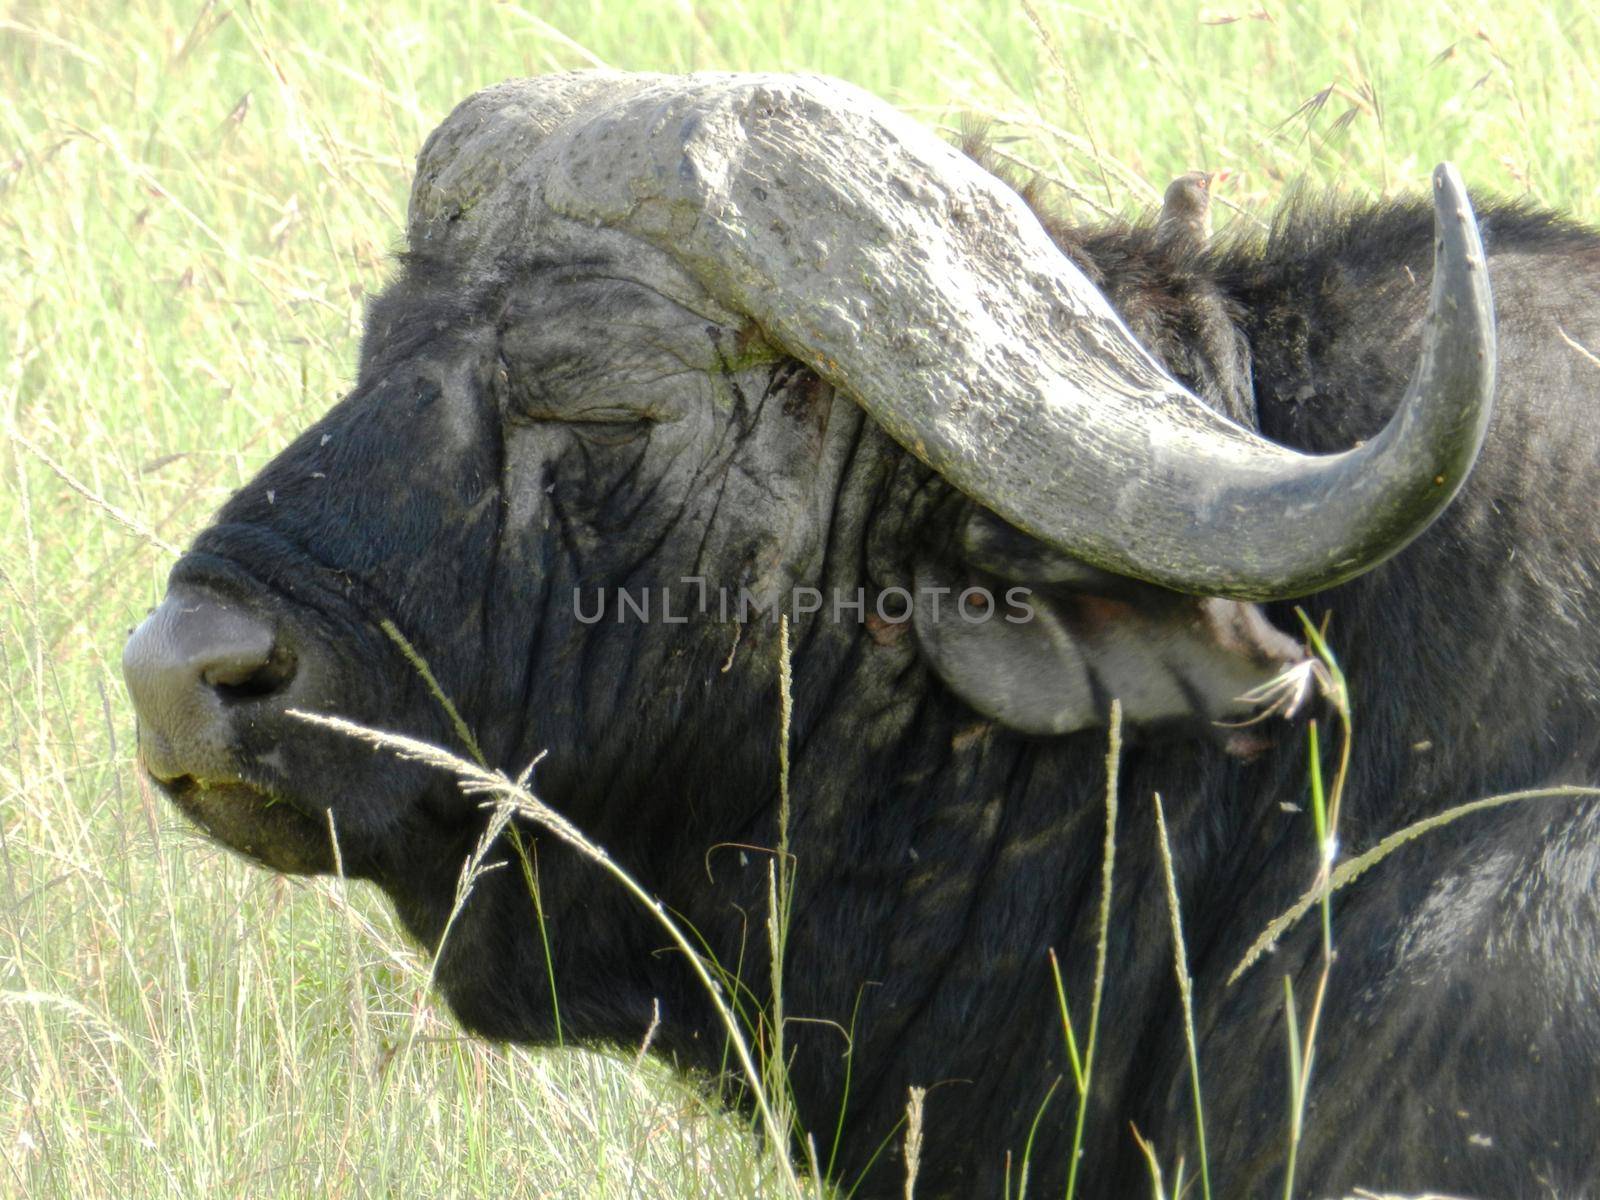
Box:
413, 72, 1494, 600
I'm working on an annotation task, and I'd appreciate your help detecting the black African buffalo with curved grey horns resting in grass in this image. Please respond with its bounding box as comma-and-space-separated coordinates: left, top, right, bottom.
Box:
125, 72, 1600, 1197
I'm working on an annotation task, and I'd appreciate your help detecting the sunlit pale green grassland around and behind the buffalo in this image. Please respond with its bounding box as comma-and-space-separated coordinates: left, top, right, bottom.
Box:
0, 0, 1600, 1197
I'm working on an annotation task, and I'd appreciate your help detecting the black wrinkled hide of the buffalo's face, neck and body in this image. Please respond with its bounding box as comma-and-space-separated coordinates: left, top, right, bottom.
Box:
134, 180, 1600, 1197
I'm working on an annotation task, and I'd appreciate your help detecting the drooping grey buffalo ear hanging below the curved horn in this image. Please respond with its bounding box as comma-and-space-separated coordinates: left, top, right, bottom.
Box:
914, 509, 1306, 754
